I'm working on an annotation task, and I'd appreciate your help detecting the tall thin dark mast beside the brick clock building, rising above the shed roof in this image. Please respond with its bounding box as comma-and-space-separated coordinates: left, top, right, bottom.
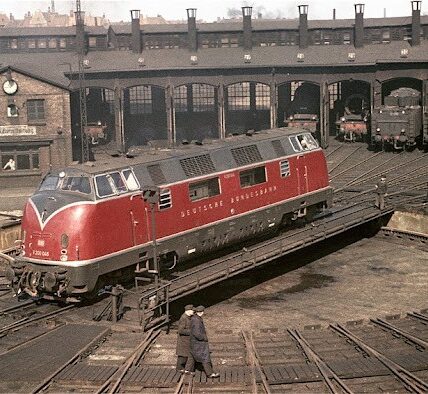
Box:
76, 0, 89, 163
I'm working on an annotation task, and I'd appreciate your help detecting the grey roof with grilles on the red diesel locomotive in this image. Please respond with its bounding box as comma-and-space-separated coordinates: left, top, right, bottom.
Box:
61, 128, 318, 185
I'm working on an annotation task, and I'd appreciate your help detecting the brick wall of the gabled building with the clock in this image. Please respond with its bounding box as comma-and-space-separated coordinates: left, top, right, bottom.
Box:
0, 70, 72, 187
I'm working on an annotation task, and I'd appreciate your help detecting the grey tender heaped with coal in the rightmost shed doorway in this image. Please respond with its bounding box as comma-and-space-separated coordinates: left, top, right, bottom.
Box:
371, 88, 426, 150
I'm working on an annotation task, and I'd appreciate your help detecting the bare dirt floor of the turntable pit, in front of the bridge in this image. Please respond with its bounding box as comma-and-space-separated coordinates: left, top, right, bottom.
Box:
191, 237, 428, 331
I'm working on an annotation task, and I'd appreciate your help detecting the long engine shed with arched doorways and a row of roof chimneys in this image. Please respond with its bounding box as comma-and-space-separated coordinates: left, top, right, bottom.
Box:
0, 1, 428, 186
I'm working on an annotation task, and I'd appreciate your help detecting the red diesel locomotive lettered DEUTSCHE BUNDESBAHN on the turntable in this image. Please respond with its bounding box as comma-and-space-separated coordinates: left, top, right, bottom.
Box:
8, 128, 332, 301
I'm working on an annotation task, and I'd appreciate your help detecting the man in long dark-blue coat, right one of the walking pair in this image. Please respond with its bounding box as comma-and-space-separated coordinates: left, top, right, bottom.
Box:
186, 306, 220, 378
